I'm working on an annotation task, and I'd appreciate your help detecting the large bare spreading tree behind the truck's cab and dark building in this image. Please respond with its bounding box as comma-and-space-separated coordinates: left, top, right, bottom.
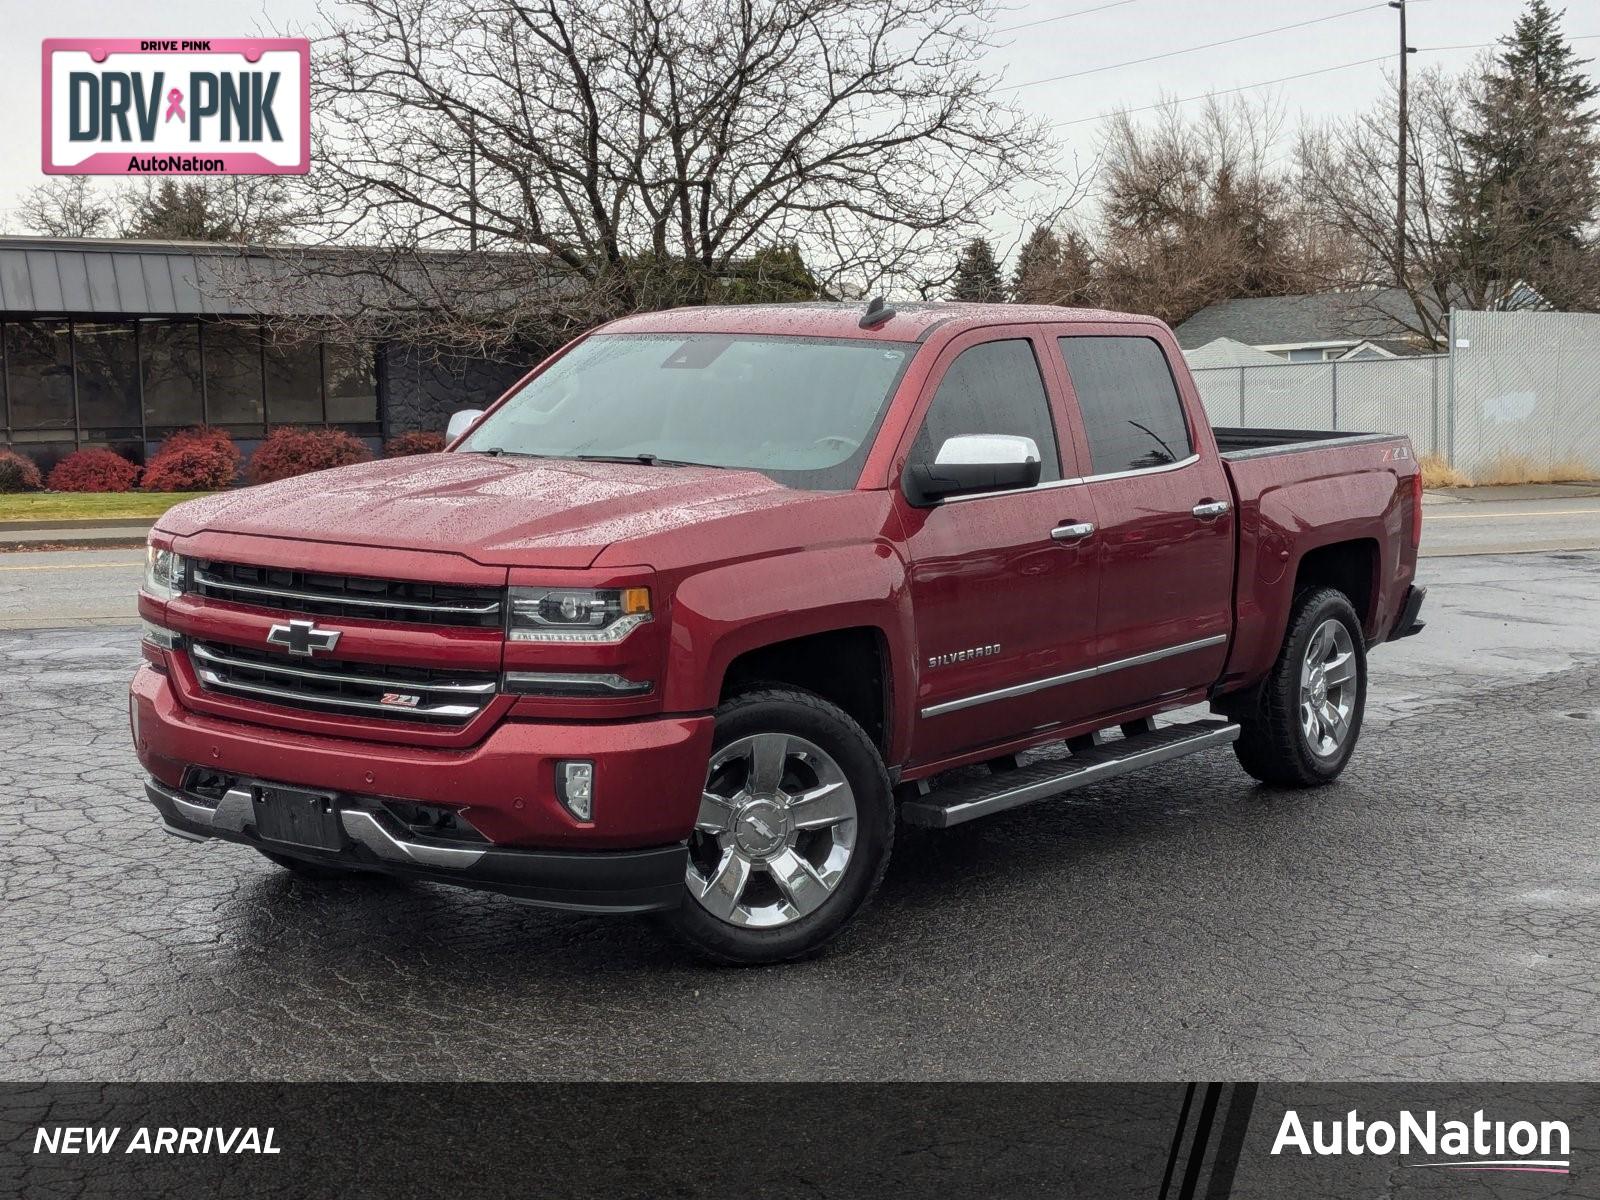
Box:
281, 0, 1050, 350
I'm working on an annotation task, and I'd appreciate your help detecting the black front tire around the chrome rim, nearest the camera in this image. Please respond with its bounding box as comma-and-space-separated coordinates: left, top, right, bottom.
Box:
667, 688, 894, 963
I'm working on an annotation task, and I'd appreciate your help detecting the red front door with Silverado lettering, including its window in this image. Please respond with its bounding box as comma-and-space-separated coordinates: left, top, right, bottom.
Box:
901, 326, 1098, 765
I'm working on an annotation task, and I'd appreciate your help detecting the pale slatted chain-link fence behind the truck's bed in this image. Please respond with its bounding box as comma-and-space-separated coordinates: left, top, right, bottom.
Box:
1194, 312, 1600, 478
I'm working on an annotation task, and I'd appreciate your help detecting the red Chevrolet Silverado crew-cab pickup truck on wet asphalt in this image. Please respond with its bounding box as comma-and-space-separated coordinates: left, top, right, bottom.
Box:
131, 301, 1424, 962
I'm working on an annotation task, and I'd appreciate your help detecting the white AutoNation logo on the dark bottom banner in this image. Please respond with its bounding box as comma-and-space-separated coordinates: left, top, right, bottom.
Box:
1272, 1109, 1573, 1174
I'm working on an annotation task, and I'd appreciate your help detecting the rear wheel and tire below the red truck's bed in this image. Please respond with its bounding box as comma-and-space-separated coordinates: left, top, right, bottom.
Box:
1234, 587, 1366, 787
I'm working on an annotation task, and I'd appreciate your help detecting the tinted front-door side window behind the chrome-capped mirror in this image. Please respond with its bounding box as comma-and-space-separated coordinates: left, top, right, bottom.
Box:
912, 338, 1061, 480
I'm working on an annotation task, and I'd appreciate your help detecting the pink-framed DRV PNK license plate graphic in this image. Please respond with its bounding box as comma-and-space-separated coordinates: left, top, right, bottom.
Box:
43, 37, 310, 174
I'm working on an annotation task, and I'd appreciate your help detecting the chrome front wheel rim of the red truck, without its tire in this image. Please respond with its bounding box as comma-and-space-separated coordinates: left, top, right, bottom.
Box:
686, 733, 856, 930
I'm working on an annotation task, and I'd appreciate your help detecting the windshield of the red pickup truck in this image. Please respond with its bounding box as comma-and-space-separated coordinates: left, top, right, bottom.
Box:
461, 334, 917, 490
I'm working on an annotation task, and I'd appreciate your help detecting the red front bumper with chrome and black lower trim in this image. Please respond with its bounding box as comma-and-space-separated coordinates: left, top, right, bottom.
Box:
130, 666, 712, 912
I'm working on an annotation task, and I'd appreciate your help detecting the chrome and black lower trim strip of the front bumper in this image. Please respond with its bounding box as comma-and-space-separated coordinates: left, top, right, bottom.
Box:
144, 779, 688, 912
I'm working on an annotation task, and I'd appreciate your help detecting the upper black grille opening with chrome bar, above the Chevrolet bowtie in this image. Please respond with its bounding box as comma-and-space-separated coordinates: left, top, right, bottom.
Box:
189, 558, 504, 629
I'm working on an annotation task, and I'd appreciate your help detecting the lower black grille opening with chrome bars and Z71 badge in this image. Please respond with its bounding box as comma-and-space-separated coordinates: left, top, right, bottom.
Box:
189, 642, 498, 725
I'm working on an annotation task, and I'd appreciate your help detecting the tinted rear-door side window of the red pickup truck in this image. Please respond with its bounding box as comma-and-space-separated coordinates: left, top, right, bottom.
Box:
1059, 338, 1194, 475
